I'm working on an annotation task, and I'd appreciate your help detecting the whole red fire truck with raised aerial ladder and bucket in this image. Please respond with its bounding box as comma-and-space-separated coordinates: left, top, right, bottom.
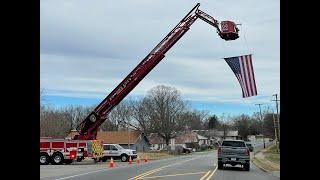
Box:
40, 3, 239, 164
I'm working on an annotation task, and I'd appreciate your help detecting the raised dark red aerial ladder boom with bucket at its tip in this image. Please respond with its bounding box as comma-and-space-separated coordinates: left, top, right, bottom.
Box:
73, 3, 239, 140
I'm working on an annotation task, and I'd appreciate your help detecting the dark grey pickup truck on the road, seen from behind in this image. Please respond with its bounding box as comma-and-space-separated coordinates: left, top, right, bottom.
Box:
218, 140, 250, 171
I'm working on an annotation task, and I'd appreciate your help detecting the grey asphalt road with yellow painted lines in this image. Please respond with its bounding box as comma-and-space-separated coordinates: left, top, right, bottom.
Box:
40, 151, 280, 180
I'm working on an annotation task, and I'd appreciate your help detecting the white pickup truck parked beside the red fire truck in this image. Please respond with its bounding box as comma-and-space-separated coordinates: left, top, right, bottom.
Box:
101, 144, 137, 162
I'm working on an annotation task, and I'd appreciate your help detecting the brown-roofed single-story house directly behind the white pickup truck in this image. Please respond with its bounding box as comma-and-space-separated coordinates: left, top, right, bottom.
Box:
67, 130, 150, 152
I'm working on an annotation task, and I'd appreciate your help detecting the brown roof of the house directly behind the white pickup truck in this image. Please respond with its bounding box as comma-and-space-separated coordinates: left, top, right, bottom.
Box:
67, 131, 148, 144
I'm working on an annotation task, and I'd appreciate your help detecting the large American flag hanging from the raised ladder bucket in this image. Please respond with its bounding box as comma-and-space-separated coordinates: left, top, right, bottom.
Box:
224, 54, 257, 98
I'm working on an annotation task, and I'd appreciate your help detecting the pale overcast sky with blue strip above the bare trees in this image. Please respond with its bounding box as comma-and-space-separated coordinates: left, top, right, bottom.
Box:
40, 0, 280, 114
